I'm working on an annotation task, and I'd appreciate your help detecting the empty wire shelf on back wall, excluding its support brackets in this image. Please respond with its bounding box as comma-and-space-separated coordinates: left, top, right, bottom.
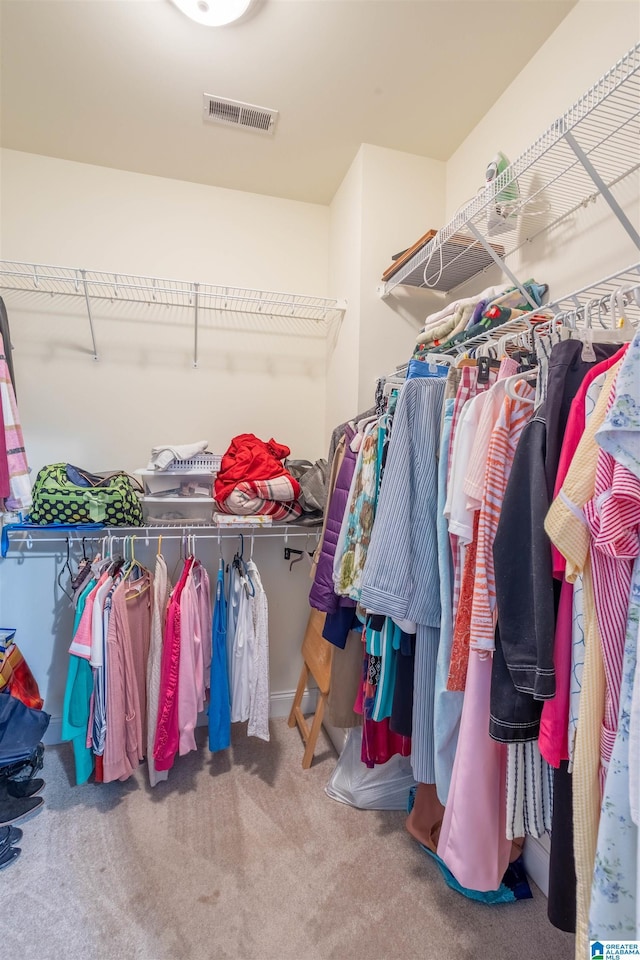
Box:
0, 260, 345, 324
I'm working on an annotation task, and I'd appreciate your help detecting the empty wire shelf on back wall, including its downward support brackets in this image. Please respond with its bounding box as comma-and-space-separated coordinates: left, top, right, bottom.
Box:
0, 260, 346, 366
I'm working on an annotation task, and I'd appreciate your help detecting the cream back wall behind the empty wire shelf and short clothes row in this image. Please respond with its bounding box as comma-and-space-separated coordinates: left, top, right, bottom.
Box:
0, 150, 329, 736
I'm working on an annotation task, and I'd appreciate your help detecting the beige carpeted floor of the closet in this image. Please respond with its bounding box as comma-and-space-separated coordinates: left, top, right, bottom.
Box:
0, 720, 573, 960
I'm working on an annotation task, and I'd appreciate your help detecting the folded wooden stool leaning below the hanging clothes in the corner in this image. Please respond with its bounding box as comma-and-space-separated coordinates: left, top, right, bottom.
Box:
289, 610, 333, 770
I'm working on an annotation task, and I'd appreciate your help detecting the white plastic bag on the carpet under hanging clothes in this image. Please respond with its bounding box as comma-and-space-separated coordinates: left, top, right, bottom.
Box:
325, 727, 415, 810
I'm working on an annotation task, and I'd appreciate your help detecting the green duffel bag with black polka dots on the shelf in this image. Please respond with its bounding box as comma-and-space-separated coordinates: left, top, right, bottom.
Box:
29, 463, 142, 527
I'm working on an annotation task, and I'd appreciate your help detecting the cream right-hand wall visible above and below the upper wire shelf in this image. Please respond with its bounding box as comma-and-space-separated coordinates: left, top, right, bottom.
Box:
446, 0, 640, 298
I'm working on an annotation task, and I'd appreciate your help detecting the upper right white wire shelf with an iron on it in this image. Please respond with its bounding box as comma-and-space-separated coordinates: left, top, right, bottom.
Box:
378, 43, 640, 299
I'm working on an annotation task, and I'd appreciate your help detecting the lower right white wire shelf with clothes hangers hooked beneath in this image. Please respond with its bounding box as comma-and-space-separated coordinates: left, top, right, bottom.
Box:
434, 262, 640, 356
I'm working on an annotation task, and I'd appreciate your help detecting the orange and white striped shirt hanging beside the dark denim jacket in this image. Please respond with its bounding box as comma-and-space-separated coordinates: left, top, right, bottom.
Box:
470, 381, 535, 651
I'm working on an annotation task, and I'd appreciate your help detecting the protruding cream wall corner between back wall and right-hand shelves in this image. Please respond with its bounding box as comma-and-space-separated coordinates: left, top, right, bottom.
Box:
326, 143, 445, 434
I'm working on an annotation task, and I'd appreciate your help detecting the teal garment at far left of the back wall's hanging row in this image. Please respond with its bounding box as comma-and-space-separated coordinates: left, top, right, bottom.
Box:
62, 579, 97, 785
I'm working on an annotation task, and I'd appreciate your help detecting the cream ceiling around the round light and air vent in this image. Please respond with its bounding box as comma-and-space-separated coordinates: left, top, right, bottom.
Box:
0, 0, 575, 203
